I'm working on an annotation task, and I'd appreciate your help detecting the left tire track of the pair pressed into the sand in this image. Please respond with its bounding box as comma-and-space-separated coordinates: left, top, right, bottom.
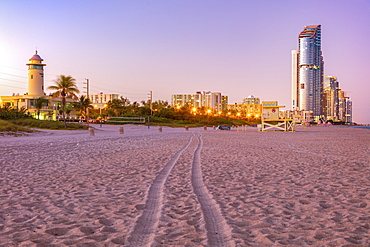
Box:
128, 136, 193, 247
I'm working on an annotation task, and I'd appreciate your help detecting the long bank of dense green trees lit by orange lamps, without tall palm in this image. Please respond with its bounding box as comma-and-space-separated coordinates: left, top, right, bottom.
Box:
83, 97, 261, 127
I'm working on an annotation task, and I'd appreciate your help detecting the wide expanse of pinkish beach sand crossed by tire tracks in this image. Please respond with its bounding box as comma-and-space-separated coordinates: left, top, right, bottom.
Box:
0, 125, 370, 247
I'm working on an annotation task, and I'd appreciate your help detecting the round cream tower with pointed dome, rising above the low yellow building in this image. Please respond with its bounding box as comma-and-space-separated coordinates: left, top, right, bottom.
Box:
26, 50, 46, 96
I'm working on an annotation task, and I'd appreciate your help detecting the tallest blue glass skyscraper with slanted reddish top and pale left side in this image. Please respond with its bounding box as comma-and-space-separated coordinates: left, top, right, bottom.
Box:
292, 25, 324, 118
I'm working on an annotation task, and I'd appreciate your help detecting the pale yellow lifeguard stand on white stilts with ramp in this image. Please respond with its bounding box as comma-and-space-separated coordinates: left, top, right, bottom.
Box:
258, 101, 294, 132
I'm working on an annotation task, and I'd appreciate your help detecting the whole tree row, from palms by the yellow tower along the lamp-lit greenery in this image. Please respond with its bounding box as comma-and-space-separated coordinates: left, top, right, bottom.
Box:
2, 75, 249, 127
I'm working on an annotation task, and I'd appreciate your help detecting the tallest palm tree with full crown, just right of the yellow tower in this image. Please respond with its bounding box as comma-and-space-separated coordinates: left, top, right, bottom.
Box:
48, 75, 80, 128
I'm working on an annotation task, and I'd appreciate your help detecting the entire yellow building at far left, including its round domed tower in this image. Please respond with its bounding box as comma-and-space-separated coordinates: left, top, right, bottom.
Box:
0, 51, 74, 120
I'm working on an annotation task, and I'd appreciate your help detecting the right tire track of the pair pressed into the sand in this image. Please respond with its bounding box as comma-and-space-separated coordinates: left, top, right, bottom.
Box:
191, 135, 235, 247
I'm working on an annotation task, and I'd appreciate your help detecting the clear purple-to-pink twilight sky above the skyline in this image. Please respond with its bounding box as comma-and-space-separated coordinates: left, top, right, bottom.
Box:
0, 0, 370, 123
